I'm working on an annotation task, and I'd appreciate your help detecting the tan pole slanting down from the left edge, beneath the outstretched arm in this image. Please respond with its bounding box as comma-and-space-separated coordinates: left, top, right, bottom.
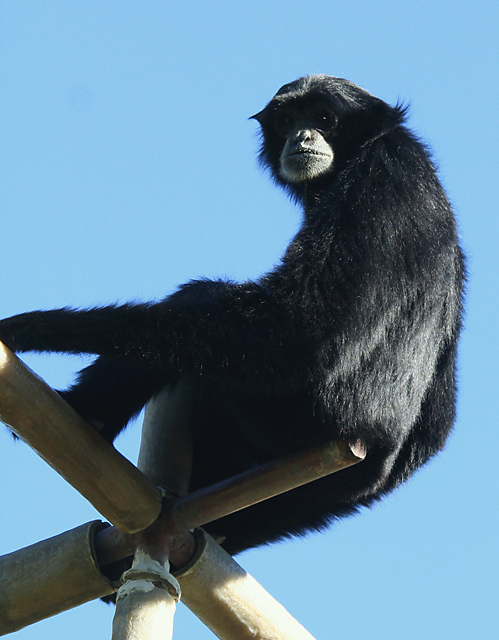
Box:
0, 342, 162, 532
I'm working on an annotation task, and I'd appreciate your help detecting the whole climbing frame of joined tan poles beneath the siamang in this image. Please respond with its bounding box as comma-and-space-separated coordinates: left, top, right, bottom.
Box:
0, 343, 365, 640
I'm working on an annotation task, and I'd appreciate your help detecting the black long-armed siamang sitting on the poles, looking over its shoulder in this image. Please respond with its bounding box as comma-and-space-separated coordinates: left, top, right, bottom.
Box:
0, 75, 465, 553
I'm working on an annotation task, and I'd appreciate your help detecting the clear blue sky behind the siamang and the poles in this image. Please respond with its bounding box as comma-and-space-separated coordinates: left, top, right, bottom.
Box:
0, 0, 499, 640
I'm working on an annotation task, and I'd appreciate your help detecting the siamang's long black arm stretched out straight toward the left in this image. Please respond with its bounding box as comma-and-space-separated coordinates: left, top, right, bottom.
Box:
0, 282, 304, 383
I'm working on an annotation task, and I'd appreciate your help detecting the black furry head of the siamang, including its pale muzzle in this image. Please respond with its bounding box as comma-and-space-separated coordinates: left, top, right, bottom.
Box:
252, 75, 404, 199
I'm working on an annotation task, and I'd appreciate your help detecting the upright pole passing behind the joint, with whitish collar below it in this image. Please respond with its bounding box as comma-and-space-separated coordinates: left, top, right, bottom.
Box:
112, 384, 192, 640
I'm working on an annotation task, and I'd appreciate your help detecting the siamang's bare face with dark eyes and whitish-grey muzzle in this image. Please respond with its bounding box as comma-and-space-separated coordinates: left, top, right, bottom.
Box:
274, 108, 335, 183
